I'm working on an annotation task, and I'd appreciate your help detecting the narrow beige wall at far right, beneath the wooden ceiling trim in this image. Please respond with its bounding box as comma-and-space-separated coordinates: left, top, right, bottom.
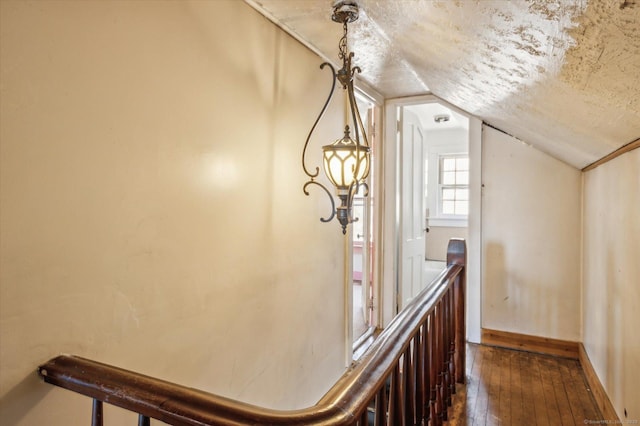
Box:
582, 149, 640, 421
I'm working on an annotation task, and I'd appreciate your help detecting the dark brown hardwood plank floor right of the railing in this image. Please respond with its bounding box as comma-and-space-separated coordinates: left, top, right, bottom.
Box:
449, 344, 602, 426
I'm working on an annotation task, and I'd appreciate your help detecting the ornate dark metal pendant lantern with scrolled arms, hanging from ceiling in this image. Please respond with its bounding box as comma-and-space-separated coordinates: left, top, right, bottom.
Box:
302, 1, 370, 234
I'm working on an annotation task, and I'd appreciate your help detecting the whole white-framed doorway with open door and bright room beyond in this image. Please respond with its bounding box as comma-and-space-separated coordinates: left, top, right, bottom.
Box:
382, 95, 482, 342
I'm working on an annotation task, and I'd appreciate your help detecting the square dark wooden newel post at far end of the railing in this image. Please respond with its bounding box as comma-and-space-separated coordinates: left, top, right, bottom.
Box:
447, 238, 467, 383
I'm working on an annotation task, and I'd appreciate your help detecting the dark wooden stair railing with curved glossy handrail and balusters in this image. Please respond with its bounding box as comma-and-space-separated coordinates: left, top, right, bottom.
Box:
38, 240, 466, 426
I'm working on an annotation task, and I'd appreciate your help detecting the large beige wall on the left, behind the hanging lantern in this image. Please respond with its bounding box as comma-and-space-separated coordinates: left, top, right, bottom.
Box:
0, 0, 345, 425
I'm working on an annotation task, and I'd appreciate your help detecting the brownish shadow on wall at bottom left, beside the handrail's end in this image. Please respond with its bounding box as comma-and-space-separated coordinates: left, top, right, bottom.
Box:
0, 371, 53, 425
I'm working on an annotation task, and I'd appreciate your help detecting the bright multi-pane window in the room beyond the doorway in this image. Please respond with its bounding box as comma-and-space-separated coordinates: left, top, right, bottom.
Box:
438, 155, 469, 216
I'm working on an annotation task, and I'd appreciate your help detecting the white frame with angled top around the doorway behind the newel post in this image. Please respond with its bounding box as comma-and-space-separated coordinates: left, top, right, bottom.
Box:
379, 95, 482, 343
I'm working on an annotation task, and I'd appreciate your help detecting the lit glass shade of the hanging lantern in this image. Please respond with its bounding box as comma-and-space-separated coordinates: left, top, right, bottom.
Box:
322, 127, 369, 191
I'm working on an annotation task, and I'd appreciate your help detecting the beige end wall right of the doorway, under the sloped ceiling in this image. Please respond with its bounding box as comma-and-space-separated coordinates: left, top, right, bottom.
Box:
482, 126, 581, 341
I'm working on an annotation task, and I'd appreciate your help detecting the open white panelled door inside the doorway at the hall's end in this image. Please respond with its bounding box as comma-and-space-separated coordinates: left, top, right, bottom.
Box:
398, 108, 427, 309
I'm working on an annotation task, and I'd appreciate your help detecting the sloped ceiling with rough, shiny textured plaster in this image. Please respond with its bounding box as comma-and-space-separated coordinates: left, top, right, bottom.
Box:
247, 0, 640, 168
